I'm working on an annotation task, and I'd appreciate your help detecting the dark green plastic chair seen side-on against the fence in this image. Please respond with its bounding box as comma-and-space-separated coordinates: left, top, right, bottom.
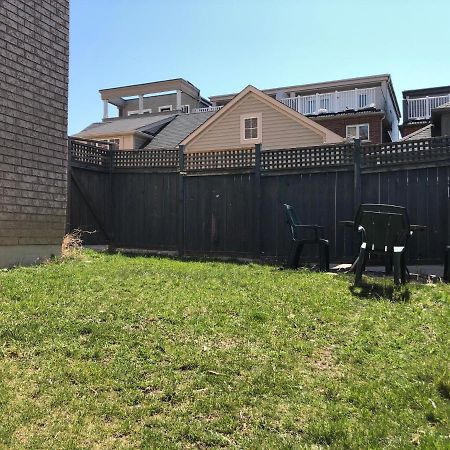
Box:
284, 204, 330, 272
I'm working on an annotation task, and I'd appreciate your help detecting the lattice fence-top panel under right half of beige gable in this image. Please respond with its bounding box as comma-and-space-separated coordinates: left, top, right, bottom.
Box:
261, 145, 353, 170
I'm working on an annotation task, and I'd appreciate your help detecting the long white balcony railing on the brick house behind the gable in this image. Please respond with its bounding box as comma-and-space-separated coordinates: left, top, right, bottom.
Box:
280, 87, 383, 115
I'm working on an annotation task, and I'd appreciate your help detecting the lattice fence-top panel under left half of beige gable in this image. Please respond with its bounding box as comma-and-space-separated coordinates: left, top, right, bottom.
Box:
184, 148, 255, 171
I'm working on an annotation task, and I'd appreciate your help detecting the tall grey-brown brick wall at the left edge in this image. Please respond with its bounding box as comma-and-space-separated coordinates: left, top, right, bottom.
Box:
0, 0, 69, 246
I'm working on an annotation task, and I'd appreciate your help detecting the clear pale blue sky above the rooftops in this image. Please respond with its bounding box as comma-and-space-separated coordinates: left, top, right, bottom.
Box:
69, 0, 450, 134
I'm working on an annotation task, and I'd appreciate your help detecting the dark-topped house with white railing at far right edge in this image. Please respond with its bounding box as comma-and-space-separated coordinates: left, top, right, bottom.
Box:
399, 86, 450, 138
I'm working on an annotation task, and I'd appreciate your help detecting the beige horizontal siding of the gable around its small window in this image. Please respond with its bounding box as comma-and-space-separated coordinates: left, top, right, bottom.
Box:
186, 93, 324, 152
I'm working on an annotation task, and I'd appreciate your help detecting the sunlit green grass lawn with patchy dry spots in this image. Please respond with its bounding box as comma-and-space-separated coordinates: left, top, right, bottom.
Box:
0, 252, 450, 449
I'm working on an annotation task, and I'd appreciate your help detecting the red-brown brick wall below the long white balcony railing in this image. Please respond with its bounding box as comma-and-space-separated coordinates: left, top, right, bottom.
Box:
310, 113, 386, 144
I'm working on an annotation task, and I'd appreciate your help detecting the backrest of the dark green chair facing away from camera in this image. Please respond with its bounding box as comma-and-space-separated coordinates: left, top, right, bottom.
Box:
355, 205, 409, 252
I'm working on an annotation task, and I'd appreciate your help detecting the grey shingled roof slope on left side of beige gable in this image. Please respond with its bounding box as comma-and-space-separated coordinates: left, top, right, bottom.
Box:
145, 111, 214, 149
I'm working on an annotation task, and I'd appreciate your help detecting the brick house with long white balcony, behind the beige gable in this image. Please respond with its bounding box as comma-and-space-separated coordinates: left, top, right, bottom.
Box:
210, 75, 400, 143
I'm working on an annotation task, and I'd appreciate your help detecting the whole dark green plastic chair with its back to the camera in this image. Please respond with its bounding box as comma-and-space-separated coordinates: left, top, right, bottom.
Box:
355, 204, 411, 286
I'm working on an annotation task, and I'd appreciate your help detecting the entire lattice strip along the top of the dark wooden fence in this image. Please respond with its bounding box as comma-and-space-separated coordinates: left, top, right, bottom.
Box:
69, 137, 450, 172
